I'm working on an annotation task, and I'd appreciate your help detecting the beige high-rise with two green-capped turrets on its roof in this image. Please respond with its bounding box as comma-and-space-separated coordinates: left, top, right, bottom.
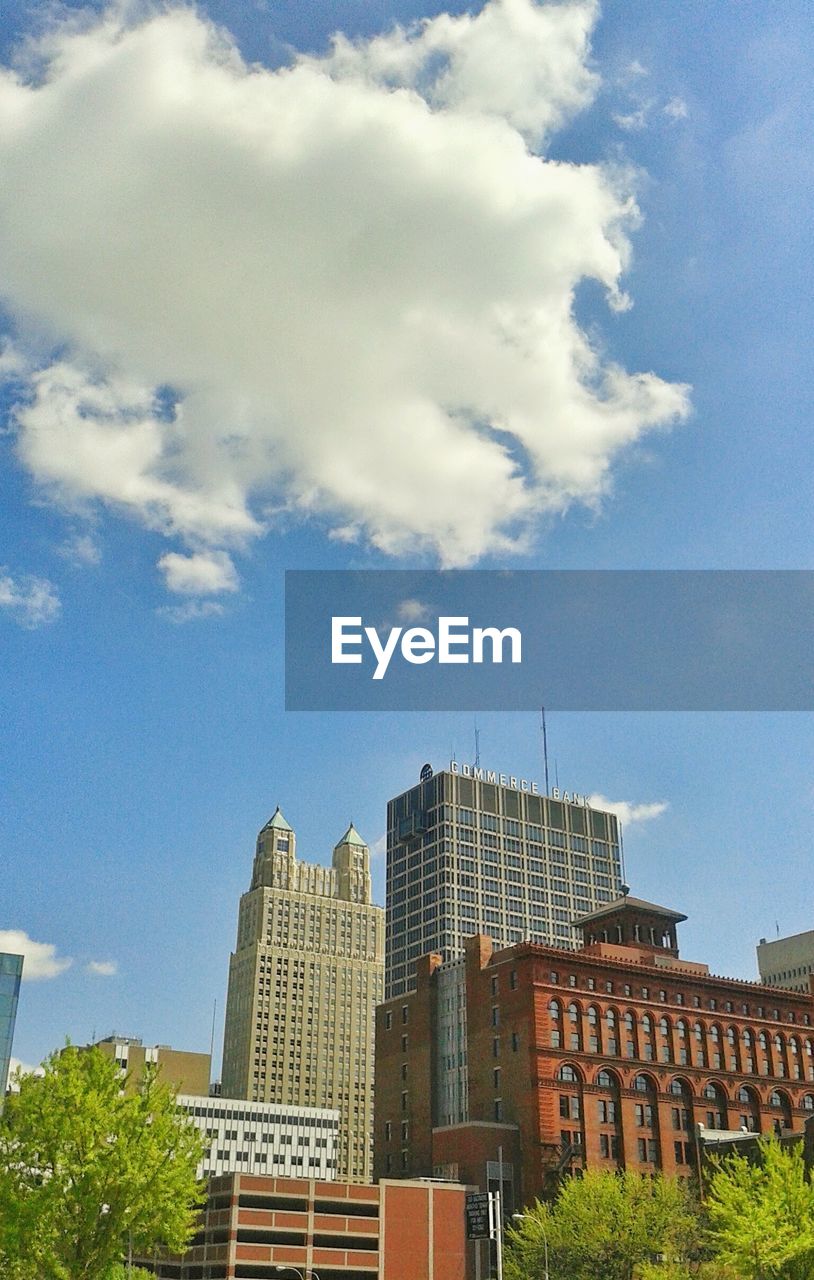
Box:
223, 808, 384, 1181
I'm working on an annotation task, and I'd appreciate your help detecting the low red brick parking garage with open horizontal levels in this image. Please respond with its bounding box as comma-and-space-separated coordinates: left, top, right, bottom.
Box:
140, 1174, 475, 1280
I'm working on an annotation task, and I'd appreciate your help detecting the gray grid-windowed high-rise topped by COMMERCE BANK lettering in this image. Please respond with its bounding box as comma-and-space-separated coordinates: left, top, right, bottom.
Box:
385, 762, 622, 1000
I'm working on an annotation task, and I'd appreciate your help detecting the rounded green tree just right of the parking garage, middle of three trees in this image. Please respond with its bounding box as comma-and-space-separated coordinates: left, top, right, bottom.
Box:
506, 1170, 699, 1280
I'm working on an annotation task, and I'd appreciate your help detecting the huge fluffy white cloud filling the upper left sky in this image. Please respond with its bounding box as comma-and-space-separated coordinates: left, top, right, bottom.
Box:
0, 0, 687, 571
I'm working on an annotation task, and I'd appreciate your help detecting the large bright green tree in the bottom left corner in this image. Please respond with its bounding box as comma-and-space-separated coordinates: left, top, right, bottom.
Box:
0, 1046, 202, 1280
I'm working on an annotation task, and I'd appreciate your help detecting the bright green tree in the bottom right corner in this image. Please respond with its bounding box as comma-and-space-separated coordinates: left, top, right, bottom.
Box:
706, 1138, 814, 1280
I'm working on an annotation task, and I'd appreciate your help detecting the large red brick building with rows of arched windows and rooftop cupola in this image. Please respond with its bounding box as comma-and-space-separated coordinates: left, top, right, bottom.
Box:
374, 897, 814, 1206
